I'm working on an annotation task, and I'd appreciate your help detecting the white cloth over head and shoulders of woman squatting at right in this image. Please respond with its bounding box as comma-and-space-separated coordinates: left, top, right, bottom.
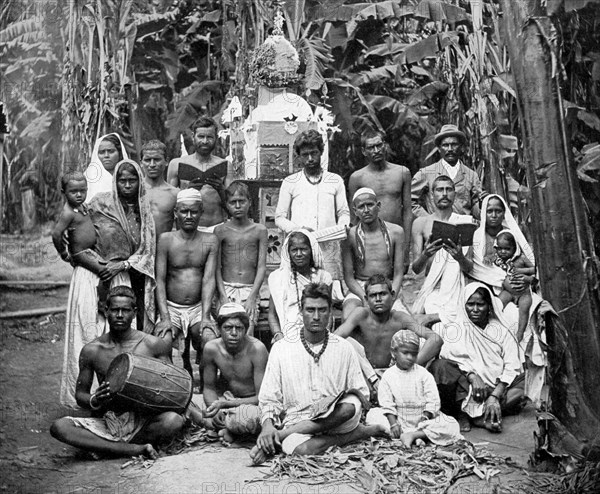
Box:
433, 282, 521, 386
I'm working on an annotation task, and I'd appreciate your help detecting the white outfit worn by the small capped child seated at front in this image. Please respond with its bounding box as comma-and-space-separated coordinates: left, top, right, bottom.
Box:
367, 364, 463, 445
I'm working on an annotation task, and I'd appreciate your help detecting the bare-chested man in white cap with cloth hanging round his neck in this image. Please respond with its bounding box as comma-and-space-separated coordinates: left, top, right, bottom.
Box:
342, 187, 407, 321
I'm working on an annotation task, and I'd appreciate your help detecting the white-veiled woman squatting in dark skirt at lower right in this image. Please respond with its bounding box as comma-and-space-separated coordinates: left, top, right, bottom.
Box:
429, 283, 523, 432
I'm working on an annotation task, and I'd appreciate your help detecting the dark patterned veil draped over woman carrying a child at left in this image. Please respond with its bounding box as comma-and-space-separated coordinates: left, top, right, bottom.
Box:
89, 160, 156, 332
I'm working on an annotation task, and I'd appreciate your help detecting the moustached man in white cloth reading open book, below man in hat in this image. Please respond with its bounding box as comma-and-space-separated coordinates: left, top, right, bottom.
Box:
412, 175, 473, 322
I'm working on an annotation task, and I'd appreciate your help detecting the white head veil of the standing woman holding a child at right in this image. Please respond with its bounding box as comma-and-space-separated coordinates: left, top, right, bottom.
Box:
469, 194, 535, 287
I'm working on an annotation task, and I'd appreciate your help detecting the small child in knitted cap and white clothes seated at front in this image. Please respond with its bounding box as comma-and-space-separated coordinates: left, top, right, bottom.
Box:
366, 329, 463, 448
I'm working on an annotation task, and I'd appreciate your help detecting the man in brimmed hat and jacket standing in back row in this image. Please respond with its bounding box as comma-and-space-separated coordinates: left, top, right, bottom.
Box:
411, 125, 484, 218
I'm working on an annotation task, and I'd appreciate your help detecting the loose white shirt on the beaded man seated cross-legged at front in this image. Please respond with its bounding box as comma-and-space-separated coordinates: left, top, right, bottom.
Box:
258, 334, 369, 427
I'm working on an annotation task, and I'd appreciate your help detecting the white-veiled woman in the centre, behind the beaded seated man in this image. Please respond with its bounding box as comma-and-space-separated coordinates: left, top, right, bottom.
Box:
269, 230, 333, 343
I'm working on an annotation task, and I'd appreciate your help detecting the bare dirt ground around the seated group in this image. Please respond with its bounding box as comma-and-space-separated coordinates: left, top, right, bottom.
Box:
0, 236, 556, 494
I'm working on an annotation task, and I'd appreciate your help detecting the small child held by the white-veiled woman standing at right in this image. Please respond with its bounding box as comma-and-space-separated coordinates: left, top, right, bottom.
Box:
494, 230, 535, 343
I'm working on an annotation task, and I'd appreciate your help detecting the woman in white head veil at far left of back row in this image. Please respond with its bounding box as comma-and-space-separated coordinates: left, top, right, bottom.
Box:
84, 132, 127, 203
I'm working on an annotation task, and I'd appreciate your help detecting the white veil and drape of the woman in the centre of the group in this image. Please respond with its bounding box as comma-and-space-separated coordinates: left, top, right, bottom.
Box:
268, 229, 333, 338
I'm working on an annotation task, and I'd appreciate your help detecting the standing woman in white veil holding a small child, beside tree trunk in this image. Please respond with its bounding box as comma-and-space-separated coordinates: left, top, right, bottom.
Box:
469, 194, 553, 403
